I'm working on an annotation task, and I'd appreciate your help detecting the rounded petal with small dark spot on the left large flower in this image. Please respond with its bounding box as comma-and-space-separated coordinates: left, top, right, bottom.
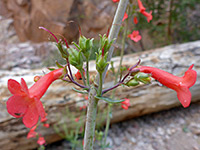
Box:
7, 95, 28, 118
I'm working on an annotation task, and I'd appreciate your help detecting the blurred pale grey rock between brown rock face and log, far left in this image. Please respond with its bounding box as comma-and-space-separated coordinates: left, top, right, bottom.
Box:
0, 42, 58, 70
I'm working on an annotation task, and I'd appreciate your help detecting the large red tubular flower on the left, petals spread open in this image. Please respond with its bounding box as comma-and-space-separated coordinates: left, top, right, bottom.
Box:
7, 68, 63, 128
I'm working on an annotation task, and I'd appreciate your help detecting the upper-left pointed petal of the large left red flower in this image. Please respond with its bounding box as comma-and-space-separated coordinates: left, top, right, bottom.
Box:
8, 79, 24, 95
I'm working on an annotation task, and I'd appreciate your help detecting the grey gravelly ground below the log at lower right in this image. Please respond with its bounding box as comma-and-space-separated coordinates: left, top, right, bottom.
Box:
46, 103, 200, 150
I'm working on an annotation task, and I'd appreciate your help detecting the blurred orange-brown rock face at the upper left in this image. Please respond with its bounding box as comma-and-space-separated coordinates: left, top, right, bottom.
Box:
0, 0, 115, 42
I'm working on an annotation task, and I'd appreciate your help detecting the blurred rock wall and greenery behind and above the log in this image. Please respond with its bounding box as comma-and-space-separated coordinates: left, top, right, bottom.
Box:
0, 0, 200, 69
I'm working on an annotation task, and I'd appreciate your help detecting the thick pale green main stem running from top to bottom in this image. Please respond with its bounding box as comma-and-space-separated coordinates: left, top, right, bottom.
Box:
83, 0, 128, 150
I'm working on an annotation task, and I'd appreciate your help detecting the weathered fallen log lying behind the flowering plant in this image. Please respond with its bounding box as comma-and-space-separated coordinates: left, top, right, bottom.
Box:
0, 41, 200, 150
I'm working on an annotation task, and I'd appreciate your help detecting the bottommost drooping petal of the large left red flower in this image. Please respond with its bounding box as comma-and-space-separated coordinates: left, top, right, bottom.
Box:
23, 103, 39, 128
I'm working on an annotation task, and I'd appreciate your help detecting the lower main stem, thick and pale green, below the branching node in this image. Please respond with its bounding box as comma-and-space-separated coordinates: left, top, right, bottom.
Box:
83, 85, 98, 150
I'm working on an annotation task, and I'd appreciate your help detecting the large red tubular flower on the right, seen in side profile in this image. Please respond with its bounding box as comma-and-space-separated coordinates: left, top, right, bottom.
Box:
139, 65, 197, 107
